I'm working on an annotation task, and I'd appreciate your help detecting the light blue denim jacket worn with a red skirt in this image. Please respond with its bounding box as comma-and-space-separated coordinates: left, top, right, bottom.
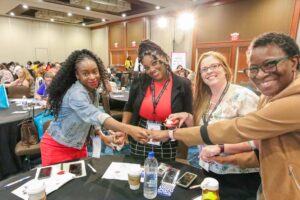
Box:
47, 81, 110, 149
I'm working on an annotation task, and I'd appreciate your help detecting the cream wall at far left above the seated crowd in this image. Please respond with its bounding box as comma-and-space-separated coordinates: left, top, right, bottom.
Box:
0, 17, 92, 64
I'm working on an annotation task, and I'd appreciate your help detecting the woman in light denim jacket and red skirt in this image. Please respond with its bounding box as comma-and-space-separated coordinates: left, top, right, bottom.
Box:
41, 49, 147, 166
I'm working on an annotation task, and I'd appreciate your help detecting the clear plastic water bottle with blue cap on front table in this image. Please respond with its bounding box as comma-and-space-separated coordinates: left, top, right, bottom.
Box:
144, 151, 158, 199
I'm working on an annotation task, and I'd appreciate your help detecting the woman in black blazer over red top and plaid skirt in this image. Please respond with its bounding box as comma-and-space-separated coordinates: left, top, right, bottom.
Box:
123, 40, 192, 160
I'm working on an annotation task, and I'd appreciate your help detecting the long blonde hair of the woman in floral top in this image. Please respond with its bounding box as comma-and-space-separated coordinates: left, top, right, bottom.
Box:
193, 51, 232, 124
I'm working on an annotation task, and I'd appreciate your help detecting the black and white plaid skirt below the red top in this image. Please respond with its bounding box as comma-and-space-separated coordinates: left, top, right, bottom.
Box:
129, 119, 178, 161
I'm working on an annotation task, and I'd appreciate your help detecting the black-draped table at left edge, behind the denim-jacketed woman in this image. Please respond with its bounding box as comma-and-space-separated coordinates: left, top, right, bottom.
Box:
0, 102, 41, 180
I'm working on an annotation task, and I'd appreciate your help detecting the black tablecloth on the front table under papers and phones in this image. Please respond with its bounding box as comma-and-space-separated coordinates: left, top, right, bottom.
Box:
0, 155, 255, 200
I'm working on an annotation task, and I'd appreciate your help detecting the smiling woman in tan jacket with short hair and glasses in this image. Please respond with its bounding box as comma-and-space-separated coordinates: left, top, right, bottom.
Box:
152, 33, 300, 199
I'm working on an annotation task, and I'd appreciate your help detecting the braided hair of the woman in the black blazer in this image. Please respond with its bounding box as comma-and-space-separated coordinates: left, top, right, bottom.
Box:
138, 40, 170, 69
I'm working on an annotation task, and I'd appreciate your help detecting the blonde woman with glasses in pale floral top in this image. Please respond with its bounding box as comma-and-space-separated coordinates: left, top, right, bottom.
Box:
169, 51, 260, 199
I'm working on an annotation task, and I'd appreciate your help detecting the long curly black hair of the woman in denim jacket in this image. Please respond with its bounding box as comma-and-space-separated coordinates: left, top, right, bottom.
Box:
47, 49, 108, 118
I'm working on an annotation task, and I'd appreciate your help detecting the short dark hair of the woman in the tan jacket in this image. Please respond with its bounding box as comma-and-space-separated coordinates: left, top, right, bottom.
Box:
249, 32, 300, 69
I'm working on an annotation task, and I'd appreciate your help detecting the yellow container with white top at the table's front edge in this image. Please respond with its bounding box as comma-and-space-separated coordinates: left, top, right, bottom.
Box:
201, 177, 220, 200
